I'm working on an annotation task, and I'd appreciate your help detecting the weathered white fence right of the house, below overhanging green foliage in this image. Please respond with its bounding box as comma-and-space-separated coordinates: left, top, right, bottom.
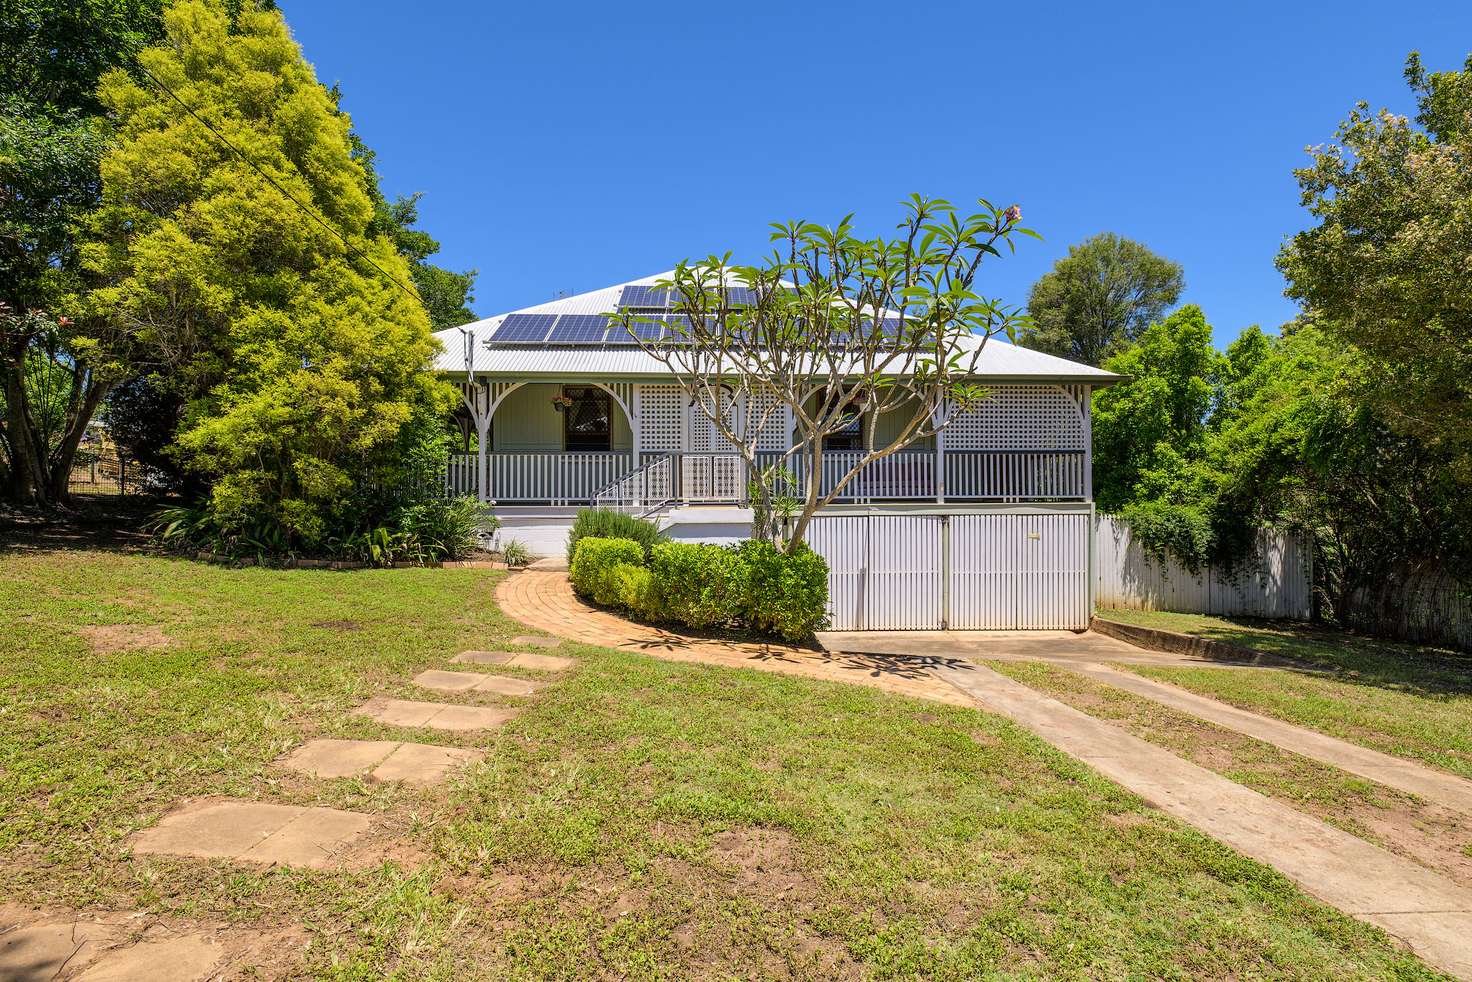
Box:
1094, 515, 1313, 620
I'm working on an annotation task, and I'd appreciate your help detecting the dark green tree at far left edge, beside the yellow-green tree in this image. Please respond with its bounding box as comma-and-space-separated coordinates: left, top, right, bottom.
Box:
0, 0, 163, 502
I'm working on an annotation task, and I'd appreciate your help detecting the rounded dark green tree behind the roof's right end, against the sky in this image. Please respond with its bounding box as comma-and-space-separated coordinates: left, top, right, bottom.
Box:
1020, 233, 1185, 365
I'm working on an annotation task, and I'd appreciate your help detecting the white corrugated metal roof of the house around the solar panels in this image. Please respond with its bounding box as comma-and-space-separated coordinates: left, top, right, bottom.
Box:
434, 272, 1119, 384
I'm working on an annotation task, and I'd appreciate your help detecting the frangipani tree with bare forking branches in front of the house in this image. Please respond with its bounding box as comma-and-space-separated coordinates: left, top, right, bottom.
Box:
618, 194, 1038, 552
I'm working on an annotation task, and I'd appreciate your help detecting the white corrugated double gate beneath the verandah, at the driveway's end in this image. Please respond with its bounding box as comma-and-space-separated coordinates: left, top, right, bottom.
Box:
808, 512, 1089, 630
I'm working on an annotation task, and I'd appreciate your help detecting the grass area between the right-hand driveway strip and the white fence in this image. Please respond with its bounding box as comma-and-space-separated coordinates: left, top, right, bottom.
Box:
1100, 610, 1472, 777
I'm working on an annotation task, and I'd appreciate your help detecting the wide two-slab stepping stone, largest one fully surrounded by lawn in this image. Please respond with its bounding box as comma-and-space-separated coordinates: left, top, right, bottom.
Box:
132, 801, 369, 870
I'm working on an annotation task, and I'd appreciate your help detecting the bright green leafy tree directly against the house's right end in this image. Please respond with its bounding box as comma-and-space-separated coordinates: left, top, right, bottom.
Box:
1094, 305, 1229, 511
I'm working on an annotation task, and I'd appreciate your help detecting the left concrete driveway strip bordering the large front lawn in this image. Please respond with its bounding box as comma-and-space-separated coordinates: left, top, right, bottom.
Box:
935, 665, 1472, 979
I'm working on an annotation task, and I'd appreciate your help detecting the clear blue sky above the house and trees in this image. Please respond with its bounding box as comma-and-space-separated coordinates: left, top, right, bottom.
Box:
281, 0, 1472, 345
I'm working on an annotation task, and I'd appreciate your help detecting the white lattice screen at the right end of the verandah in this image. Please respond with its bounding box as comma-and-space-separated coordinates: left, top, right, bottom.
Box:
945, 386, 1085, 451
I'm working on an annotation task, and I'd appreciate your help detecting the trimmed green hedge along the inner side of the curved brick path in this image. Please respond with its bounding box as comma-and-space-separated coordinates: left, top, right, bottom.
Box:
570, 536, 827, 642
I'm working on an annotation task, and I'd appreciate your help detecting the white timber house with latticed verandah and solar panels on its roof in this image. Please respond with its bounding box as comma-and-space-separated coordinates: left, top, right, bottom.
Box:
436, 274, 1117, 630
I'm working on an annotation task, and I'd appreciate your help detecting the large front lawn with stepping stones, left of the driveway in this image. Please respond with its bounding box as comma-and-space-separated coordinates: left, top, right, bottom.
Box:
0, 551, 1435, 979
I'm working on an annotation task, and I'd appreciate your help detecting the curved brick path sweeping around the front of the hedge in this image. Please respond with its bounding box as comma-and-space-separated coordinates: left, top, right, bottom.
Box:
496, 570, 973, 705
